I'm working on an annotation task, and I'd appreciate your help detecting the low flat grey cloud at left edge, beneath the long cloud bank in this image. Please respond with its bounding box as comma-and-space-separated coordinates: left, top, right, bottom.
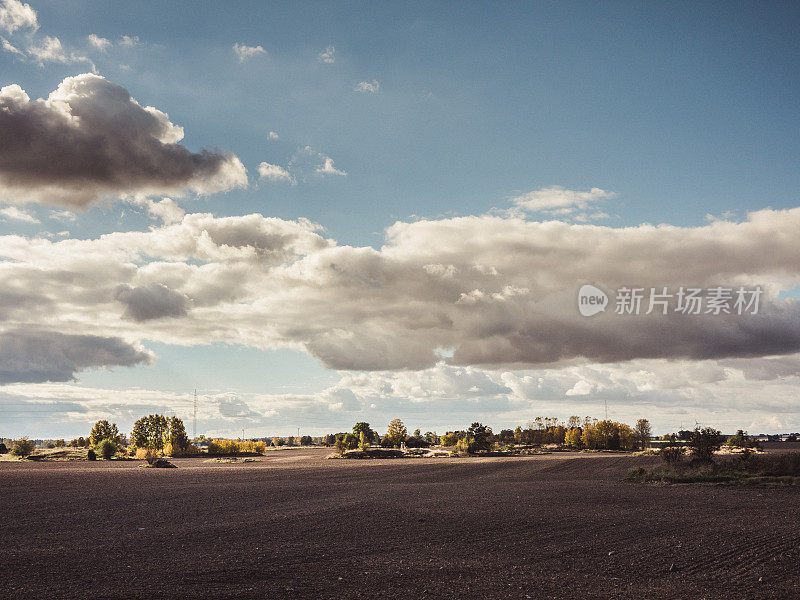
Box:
0, 330, 153, 384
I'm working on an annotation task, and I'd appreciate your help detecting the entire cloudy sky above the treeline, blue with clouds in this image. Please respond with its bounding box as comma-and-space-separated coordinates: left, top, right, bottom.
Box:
0, 0, 800, 438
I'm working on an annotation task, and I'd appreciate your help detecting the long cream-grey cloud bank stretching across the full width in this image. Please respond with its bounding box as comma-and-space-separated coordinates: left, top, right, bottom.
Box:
0, 208, 800, 380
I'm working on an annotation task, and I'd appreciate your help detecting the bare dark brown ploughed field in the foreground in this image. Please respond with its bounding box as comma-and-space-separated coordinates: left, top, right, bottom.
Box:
0, 450, 800, 600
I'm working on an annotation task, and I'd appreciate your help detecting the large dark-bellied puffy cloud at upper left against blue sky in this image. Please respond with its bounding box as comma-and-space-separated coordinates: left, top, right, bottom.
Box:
0, 73, 247, 208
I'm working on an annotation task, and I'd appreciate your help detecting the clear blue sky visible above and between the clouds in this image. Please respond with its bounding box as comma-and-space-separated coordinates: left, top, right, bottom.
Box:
0, 0, 800, 435
